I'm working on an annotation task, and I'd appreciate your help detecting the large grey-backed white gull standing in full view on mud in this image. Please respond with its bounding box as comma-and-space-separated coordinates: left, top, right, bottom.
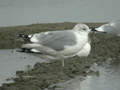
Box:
17, 24, 94, 66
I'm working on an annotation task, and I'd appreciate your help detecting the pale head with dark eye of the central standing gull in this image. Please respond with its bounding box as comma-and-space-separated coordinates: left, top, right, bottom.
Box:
73, 23, 90, 33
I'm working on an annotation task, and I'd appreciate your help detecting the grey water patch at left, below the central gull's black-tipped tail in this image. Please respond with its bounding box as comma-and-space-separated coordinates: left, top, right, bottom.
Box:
0, 49, 48, 85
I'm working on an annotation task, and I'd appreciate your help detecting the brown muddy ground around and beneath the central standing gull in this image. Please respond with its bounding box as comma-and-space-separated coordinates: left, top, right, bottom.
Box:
0, 23, 120, 90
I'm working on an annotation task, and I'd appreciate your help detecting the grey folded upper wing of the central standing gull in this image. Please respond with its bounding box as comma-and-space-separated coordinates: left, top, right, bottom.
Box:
31, 30, 76, 50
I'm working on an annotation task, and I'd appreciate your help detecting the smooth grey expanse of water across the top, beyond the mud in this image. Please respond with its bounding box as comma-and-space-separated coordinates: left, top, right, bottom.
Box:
0, 0, 120, 26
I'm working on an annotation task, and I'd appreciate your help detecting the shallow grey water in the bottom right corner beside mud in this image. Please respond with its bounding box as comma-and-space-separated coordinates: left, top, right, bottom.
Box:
55, 62, 120, 90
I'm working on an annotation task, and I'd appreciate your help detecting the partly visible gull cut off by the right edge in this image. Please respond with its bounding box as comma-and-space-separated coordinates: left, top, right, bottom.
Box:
95, 20, 120, 36
